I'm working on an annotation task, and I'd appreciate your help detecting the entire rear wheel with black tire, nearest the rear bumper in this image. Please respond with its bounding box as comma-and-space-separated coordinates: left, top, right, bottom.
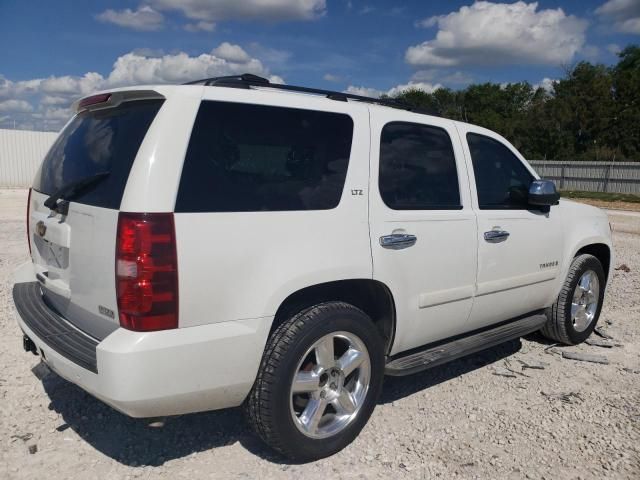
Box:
245, 302, 384, 462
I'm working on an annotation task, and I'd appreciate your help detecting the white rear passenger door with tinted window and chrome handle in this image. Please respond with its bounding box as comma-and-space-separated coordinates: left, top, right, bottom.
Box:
369, 109, 477, 353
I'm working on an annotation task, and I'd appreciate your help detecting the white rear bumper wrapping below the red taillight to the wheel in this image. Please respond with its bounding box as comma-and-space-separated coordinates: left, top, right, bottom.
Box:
14, 262, 273, 417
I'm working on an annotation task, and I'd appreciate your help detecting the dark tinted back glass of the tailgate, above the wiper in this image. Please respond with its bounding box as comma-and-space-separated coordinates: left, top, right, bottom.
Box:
33, 100, 163, 209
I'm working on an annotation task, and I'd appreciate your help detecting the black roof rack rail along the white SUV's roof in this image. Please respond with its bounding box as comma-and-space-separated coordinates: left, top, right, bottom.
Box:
183, 73, 436, 115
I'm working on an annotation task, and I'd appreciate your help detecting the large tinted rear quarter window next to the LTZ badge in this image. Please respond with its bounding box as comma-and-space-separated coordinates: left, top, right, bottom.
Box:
176, 101, 353, 212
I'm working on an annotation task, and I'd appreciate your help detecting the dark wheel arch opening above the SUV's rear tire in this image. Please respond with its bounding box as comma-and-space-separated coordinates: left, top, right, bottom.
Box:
269, 278, 396, 354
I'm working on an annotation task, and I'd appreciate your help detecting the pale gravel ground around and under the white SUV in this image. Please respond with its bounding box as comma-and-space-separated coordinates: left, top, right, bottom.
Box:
0, 190, 640, 479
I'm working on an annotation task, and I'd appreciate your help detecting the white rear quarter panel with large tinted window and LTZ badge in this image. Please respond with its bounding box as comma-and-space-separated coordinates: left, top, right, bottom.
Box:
175, 87, 371, 328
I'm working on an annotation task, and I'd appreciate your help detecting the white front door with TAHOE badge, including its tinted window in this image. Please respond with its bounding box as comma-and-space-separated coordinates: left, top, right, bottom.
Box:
458, 124, 563, 330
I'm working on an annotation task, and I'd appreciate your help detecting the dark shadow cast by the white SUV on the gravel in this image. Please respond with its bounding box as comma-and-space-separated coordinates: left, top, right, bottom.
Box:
42, 340, 520, 467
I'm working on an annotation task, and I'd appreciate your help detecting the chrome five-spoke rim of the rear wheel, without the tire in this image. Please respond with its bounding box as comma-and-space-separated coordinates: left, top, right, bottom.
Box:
290, 332, 371, 438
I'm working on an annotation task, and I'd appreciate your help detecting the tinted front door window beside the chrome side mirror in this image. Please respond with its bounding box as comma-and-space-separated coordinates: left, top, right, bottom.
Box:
467, 133, 533, 210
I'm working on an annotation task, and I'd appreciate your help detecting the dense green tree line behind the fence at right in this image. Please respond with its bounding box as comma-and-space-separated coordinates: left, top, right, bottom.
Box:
394, 45, 640, 161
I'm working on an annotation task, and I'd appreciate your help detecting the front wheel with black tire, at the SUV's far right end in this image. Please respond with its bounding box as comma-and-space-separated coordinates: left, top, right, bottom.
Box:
541, 254, 606, 345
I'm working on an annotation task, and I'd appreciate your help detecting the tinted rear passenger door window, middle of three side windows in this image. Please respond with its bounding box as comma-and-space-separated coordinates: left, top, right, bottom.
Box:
379, 122, 462, 210
